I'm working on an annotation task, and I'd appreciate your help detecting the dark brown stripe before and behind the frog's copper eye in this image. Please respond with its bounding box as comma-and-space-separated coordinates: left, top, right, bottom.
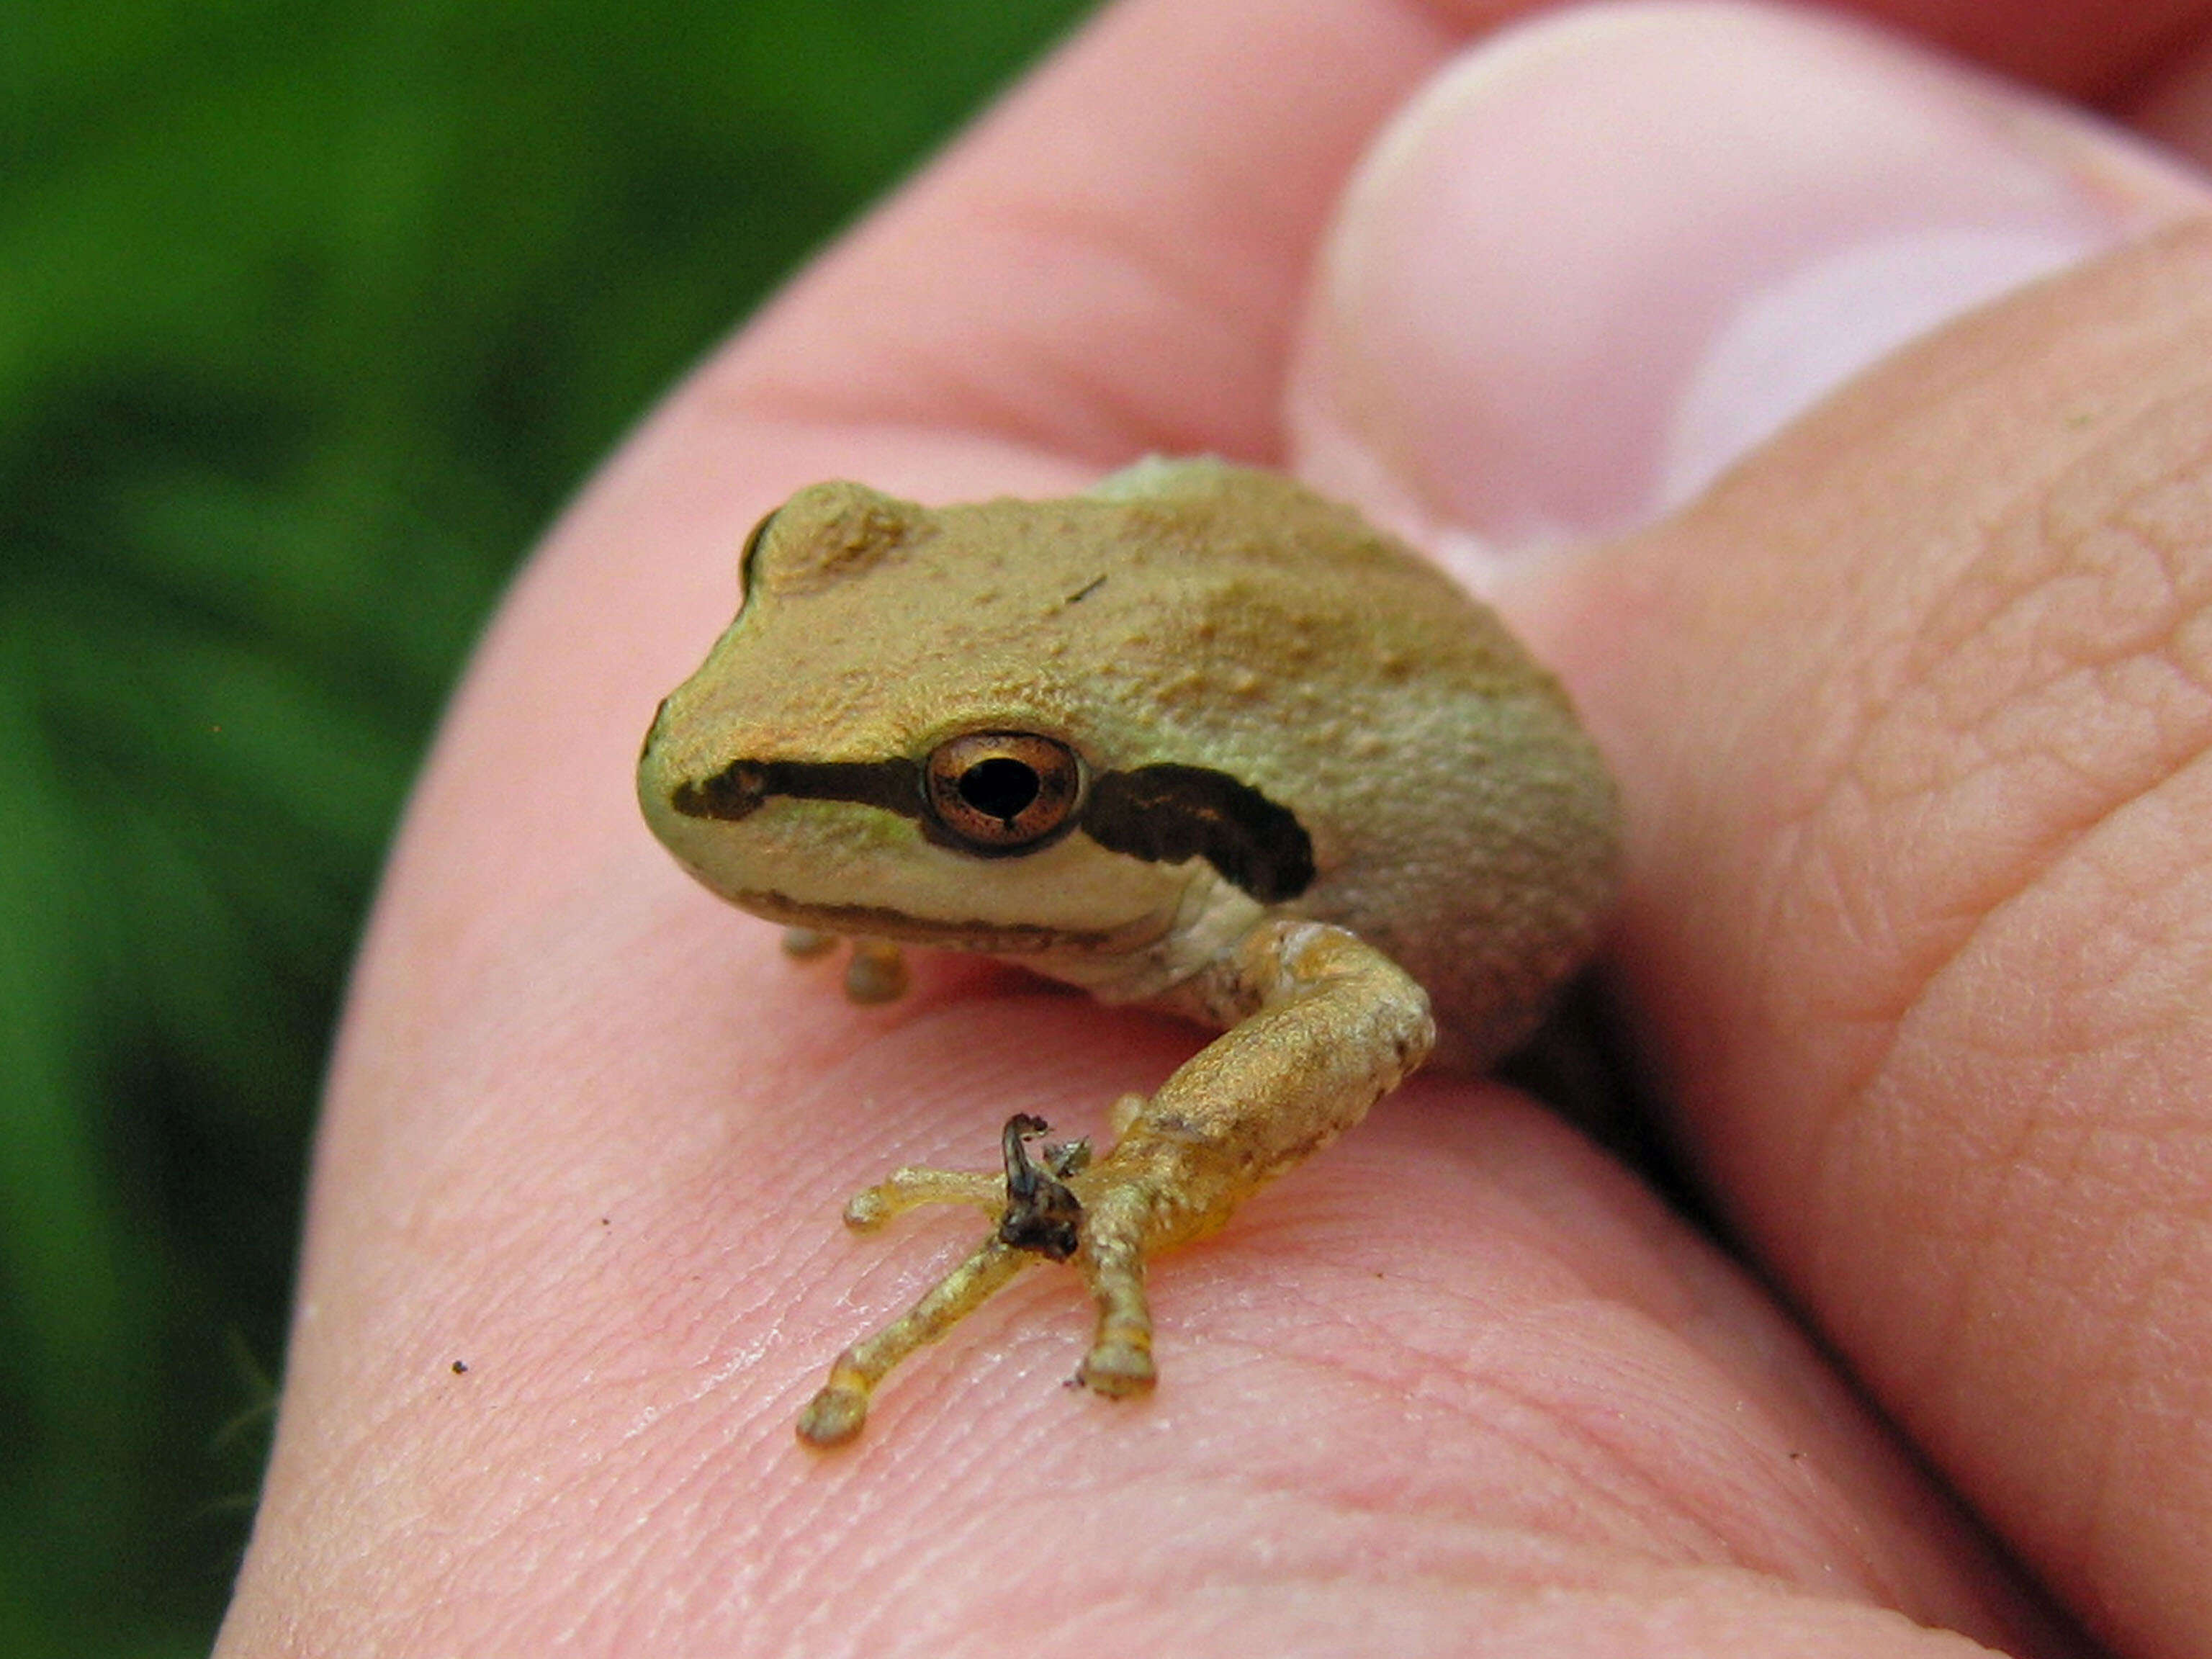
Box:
670, 759, 1314, 904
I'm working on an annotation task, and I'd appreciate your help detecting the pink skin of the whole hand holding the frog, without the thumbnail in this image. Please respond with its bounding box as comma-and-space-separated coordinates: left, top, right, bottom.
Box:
221, 0, 2212, 1657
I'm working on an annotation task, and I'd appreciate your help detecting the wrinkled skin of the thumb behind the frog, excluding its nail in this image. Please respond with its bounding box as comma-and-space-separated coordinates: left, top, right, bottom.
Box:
1610, 228, 2212, 1655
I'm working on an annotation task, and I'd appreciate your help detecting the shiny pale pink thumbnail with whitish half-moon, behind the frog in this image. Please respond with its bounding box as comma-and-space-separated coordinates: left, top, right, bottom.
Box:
1290, 0, 2206, 559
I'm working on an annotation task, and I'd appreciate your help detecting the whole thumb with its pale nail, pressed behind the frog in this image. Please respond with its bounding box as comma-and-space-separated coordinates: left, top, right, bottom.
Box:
1310, 13, 2212, 1653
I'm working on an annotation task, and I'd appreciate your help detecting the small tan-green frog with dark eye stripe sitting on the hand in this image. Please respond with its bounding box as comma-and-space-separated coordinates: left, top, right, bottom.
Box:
637, 460, 1617, 1447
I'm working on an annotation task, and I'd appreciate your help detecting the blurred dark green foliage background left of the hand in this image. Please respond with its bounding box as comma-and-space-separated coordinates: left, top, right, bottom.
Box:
0, 0, 1082, 1659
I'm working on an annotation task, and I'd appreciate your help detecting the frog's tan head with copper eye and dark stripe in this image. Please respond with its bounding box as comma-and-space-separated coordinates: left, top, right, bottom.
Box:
637, 485, 1314, 956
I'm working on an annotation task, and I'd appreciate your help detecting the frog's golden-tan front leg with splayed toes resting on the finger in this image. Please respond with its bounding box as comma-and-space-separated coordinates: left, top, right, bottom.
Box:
799, 920, 1436, 1444
